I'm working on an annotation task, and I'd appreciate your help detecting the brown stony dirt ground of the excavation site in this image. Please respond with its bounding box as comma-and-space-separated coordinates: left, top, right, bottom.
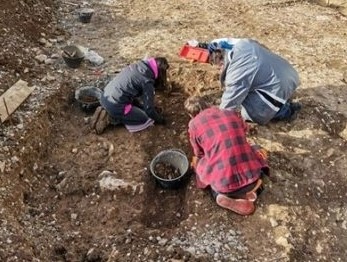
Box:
0, 0, 347, 262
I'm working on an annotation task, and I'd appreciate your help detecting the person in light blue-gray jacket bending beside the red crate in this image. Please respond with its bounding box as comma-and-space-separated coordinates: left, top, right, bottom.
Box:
208, 38, 301, 125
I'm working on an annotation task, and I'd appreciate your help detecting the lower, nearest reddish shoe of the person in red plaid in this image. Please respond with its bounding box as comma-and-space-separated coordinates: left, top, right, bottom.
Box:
216, 194, 255, 216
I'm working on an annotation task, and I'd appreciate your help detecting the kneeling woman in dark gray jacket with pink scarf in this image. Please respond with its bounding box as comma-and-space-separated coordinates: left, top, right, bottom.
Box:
91, 57, 169, 134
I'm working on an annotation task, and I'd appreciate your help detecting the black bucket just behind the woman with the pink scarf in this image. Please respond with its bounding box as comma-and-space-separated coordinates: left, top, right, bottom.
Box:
75, 86, 102, 112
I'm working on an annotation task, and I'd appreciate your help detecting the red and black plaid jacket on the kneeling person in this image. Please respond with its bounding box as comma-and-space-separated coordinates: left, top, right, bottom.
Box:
188, 107, 268, 193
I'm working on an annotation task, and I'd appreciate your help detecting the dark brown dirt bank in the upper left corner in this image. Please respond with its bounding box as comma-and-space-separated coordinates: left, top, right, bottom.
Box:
0, 0, 59, 89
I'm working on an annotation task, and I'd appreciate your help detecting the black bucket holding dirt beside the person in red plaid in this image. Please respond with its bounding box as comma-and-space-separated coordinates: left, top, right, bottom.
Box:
150, 149, 190, 189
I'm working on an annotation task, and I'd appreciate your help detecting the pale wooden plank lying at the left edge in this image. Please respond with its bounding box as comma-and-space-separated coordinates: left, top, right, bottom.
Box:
0, 80, 35, 123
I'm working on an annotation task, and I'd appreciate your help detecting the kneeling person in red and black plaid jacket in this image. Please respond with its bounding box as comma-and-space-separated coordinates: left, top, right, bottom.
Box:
184, 96, 269, 215
